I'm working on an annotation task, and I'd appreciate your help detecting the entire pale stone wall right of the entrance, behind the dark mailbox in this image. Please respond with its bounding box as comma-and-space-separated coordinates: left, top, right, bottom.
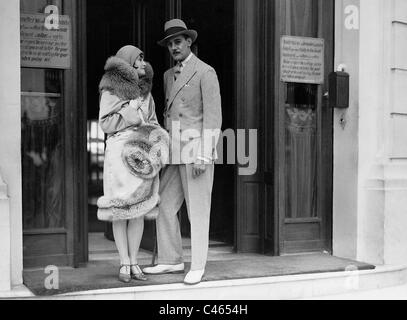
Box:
333, 0, 407, 264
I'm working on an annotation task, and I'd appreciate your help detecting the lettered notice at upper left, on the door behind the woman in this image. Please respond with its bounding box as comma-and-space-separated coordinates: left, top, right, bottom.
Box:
20, 14, 72, 69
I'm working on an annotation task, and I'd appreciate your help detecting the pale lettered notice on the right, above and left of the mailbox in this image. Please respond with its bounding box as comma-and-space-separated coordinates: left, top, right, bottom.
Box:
280, 36, 325, 84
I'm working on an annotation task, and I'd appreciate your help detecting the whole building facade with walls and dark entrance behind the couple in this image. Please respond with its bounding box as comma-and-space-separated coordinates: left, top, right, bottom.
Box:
0, 0, 407, 291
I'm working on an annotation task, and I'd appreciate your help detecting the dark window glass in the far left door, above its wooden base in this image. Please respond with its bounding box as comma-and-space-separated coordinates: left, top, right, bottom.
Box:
20, 0, 65, 231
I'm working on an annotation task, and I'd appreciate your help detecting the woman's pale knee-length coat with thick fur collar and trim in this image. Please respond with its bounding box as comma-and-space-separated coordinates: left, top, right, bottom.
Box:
97, 57, 169, 221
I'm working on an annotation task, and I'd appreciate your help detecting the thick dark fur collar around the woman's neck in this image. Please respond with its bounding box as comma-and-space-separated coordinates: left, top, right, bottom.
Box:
99, 57, 154, 100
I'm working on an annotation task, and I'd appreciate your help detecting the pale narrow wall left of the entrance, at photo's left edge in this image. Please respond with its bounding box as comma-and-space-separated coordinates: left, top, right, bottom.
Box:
0, 0, 23, 289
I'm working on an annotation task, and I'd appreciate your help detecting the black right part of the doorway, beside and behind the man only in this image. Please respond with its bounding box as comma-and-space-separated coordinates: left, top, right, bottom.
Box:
179, 0, 236, 246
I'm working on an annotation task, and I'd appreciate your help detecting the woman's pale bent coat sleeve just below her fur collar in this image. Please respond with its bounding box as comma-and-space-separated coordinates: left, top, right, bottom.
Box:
99, 91, 142, 134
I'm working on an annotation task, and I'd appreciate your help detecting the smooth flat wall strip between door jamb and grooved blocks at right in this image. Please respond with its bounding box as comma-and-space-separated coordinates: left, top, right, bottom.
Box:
357, 0, 391, 264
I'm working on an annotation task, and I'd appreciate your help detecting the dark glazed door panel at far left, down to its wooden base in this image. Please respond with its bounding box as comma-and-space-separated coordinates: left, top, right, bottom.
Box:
20, 0, 72, 268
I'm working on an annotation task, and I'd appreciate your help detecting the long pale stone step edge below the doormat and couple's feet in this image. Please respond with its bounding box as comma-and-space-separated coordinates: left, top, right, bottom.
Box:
10, 266, 407, 300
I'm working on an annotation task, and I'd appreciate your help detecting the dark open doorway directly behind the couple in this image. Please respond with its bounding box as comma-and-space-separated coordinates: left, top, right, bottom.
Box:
86, 0, 235, 258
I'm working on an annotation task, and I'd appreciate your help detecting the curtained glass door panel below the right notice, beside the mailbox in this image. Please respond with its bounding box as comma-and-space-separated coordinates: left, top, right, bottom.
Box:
285, 83, 318, 219
